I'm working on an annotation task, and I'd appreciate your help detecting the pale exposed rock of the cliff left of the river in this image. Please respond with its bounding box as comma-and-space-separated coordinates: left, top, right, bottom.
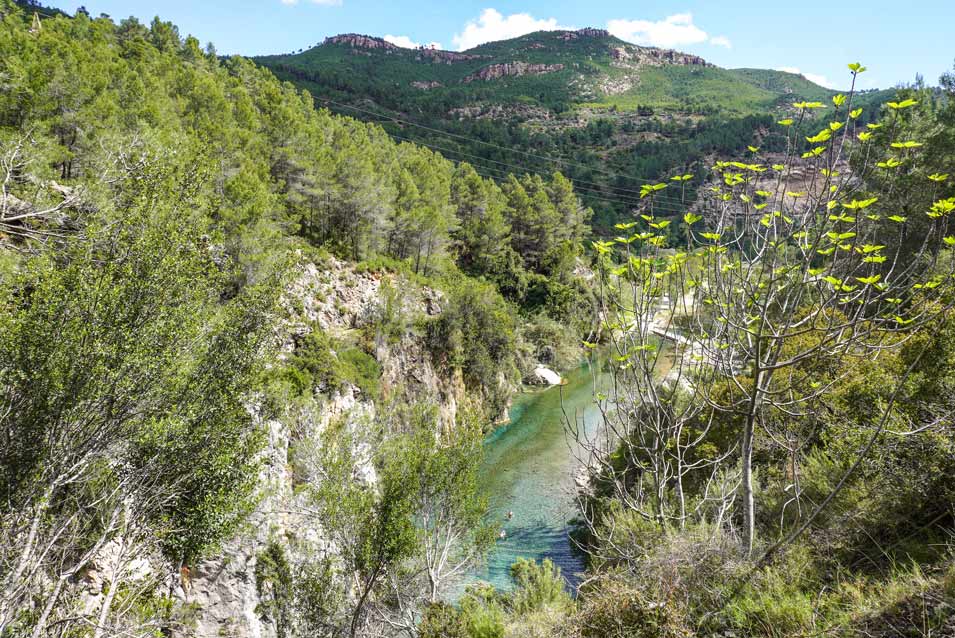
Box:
171, 258, 482, 638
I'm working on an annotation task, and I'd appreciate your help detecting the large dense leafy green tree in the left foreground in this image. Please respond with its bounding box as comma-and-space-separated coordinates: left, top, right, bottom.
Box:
0, 164, 272, 635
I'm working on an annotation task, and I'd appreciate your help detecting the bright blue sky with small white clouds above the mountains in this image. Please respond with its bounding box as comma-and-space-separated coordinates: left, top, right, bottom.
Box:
61, 0, 955, 88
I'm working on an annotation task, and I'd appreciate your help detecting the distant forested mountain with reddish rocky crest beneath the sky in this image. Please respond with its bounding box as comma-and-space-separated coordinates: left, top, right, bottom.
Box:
256, 29, 891, 234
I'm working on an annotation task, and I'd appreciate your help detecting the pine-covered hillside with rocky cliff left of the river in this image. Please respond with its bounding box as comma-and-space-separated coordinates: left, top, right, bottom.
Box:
0, 1, 594, 637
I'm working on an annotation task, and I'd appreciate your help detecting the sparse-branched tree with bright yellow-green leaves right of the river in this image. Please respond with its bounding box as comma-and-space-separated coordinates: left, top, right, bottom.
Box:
594, 63, 955, 554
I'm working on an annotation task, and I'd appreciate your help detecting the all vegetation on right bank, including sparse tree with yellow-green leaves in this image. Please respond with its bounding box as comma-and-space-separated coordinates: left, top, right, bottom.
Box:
430, 65, 955, 638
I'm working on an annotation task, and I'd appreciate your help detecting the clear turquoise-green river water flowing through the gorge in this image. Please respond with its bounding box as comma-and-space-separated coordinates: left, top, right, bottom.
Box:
464, 364, 606, 590
